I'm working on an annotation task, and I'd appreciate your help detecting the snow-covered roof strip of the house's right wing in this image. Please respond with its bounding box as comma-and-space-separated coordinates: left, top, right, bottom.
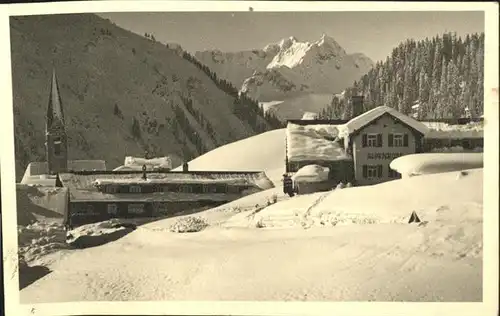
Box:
422, 122, 484, 138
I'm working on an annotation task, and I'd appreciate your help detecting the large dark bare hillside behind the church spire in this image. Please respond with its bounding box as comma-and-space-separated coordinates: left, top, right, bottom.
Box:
10, 14, 282, 178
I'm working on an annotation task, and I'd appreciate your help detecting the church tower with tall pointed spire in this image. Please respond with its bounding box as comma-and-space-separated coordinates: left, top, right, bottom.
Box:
45, 69, 68, 174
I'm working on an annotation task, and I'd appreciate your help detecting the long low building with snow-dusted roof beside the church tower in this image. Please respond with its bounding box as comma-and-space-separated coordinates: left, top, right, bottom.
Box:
58, 171, 274, 227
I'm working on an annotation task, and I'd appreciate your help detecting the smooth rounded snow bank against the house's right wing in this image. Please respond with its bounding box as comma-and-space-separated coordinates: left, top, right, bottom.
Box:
390, 153, 483, 177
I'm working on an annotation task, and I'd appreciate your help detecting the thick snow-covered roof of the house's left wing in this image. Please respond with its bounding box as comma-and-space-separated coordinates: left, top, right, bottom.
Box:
286, 123, 351, 162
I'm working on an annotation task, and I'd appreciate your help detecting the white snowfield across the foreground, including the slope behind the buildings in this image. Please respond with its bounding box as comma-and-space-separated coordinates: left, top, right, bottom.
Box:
16, 124, 483, 303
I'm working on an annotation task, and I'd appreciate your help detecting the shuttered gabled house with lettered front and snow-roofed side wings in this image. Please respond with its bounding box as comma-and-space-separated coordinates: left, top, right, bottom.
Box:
285, 99, 483, 187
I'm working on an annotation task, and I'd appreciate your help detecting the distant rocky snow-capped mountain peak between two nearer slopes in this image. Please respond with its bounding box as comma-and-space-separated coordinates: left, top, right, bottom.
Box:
195, 35, 373, 101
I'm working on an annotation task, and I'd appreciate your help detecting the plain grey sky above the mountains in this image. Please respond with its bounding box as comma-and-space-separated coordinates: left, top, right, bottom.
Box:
99, 11, 484, 61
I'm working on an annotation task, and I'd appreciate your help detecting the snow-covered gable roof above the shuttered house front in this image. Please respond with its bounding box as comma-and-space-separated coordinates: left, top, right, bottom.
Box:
340, 105, 429, 137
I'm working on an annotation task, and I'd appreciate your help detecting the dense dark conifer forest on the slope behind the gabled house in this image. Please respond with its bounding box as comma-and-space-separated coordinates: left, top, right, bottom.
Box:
320, 33, 484, 119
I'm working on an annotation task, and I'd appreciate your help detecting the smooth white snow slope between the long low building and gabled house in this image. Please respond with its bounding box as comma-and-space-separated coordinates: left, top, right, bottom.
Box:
174, 129, 285, 185
